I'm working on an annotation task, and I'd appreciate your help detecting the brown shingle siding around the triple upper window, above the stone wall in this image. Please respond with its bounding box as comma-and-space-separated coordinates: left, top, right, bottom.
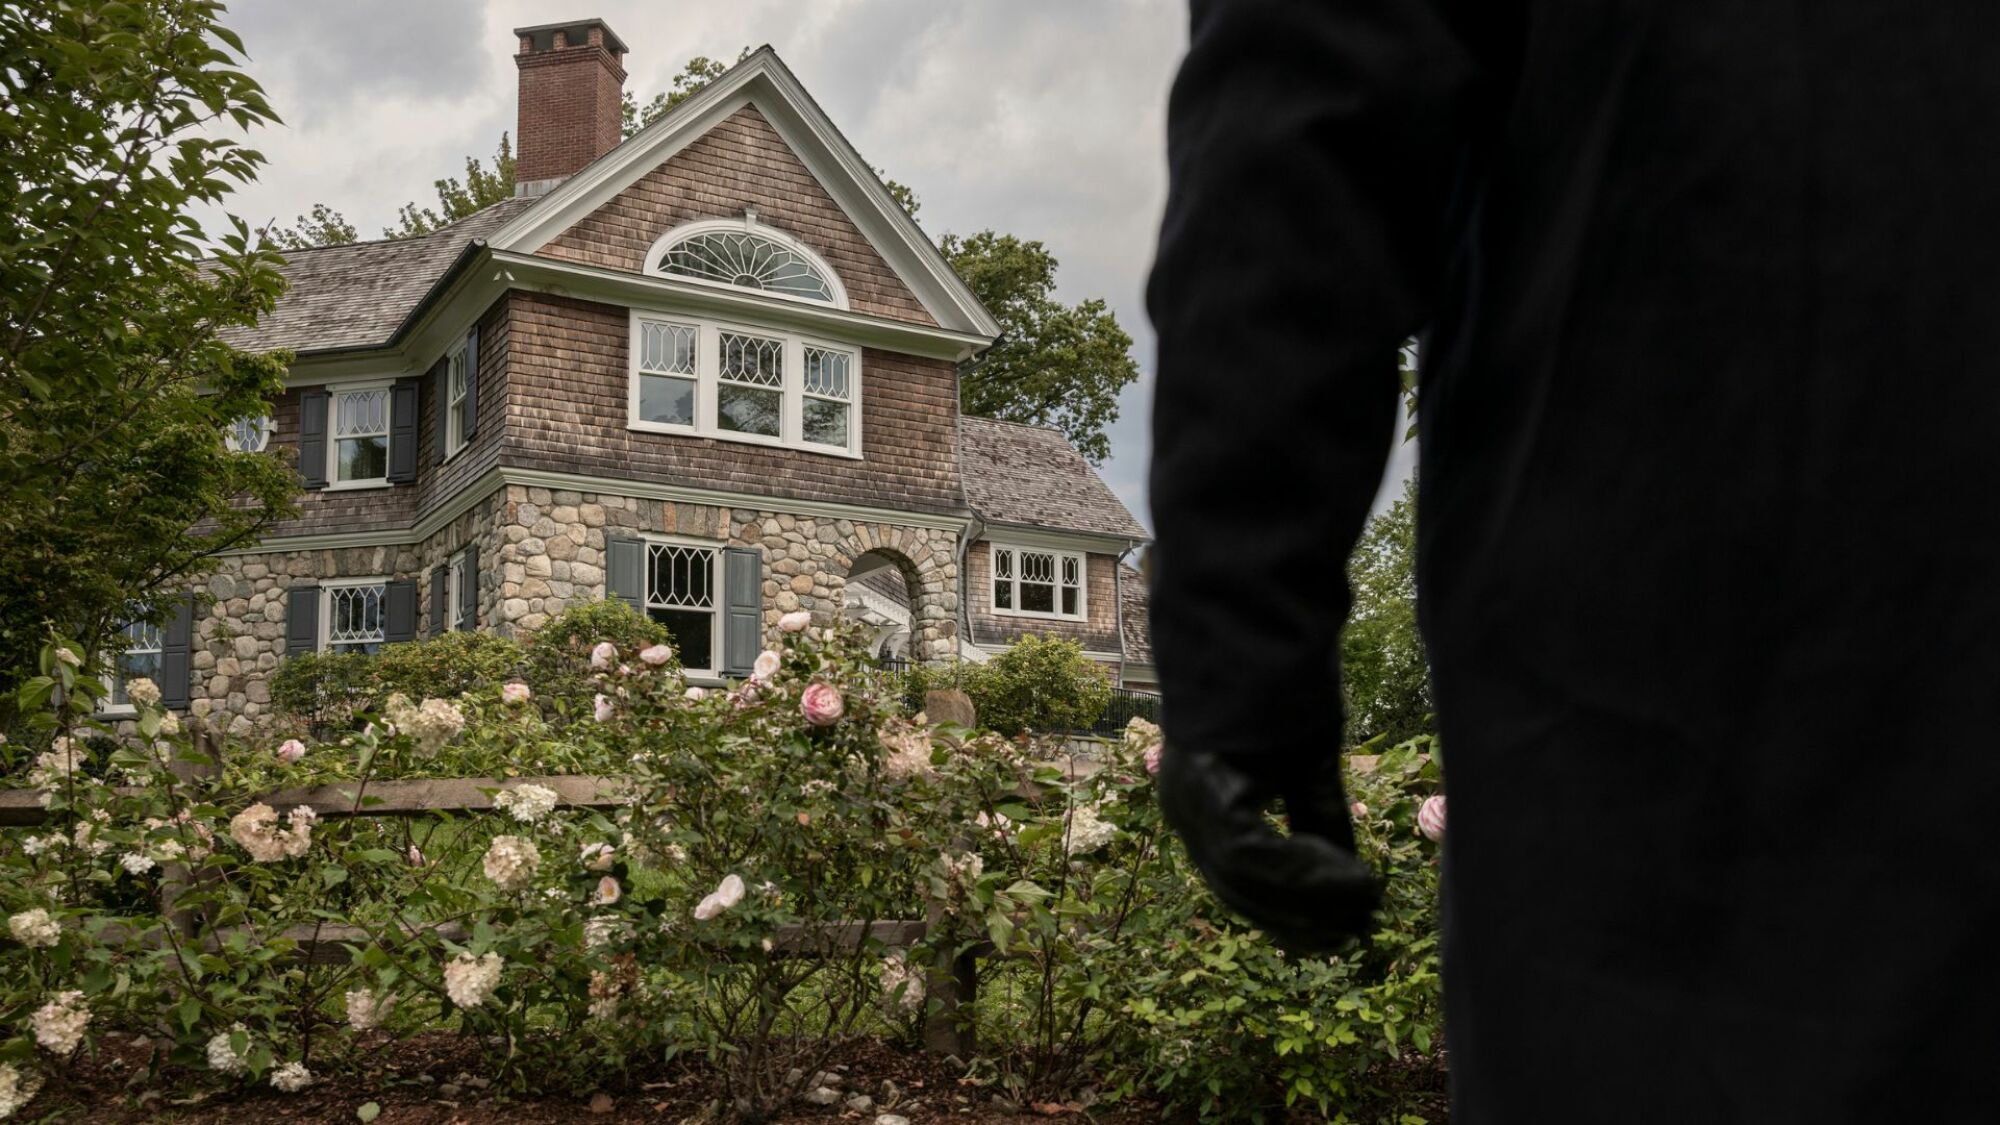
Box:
504, 292, 964, 512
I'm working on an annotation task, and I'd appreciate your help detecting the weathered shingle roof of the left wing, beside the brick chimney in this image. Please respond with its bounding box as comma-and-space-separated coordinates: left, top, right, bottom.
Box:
224, 198, 534, 352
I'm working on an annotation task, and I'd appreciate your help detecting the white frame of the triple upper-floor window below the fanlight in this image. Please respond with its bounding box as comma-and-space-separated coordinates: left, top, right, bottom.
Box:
626, 308, 864, 460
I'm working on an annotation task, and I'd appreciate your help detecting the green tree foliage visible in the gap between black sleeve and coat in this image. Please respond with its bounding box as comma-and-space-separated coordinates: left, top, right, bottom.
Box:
1340, 478, 1434, 745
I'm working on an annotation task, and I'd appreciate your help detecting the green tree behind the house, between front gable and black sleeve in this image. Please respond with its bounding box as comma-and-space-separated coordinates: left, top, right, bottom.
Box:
940, 230, 1138, 464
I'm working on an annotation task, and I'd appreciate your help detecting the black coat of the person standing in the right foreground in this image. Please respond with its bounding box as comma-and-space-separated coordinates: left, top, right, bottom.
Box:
1148, 0, 2000, 1104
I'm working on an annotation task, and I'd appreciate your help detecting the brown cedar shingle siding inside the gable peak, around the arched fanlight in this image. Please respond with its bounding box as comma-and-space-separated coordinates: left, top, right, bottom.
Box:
540, 106, 936, 324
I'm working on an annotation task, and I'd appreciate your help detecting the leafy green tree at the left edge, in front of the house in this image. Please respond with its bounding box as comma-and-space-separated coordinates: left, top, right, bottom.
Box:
0, 0, 296, 683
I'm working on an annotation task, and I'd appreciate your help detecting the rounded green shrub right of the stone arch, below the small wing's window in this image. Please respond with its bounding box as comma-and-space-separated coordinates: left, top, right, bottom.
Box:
952, 637, 1112, 735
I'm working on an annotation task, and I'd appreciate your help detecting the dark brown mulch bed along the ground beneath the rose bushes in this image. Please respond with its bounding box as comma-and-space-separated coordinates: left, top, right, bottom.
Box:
22, 1033, 1160, 1125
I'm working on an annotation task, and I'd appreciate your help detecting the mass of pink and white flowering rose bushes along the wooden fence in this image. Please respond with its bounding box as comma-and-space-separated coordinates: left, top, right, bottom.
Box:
0, 619, 1442, 1119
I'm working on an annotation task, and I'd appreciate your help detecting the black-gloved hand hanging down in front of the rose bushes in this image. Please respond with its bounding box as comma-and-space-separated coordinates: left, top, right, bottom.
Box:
1158, 743, 1382, 955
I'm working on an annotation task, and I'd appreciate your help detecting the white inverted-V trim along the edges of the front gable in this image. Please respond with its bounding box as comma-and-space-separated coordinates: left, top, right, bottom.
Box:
488, 46, 1000, 338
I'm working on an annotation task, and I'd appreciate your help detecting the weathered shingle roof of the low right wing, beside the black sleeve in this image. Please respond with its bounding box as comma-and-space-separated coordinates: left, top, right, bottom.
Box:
958, 416, 1152, 538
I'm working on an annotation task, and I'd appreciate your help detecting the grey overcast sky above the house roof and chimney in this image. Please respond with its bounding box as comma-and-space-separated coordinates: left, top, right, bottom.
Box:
203, 0, 1410, 524
